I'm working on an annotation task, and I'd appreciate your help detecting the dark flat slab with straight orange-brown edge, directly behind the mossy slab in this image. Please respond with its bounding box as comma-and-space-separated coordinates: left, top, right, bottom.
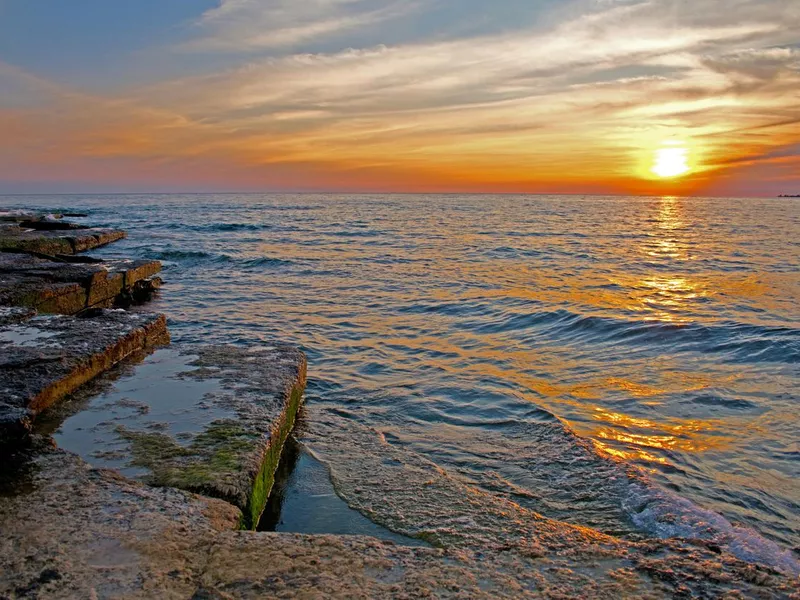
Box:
0, 307, 169, 447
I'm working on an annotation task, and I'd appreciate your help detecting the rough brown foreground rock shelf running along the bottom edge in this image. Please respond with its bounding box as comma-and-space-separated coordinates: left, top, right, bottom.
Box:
0, 447, 798, 600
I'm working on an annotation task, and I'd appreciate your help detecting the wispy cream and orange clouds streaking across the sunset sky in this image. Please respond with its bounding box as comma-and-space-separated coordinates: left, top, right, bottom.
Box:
0, 0, 800, 191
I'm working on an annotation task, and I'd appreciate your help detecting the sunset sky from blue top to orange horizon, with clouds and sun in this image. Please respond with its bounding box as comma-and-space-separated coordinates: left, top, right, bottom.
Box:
0, 0, 800, 196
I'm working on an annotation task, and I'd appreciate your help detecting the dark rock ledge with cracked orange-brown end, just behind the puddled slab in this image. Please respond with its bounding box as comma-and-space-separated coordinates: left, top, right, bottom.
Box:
0, 252, 161, 314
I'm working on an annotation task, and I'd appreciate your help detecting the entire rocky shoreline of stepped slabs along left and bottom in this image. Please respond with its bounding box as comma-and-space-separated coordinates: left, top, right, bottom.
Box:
0, 212, 798, 599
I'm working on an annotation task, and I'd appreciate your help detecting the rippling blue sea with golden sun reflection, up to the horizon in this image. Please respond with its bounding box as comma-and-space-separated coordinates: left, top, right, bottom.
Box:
0, 194, 800, 571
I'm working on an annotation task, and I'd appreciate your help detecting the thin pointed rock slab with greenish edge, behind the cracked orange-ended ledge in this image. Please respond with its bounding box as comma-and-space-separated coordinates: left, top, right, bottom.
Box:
0, 221, 126, 255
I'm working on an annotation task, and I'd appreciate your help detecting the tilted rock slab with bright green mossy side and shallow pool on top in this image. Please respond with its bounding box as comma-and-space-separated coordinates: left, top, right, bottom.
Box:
59, 345, 306, 529
